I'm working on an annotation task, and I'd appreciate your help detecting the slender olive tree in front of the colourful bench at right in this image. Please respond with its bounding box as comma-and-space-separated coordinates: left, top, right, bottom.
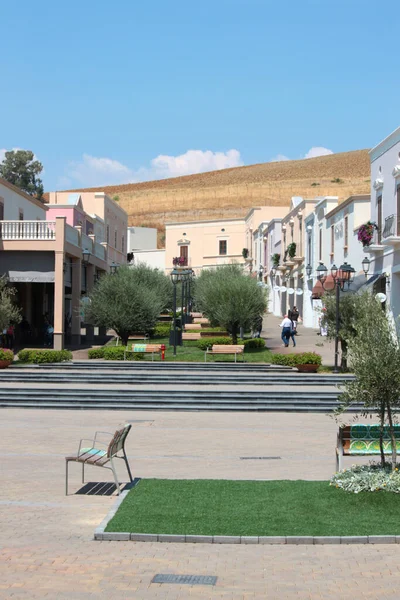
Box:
337, 292, 400, 469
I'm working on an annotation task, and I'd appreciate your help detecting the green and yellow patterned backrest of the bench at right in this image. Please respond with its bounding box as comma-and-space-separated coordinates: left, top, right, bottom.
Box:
340, 423, 400, 454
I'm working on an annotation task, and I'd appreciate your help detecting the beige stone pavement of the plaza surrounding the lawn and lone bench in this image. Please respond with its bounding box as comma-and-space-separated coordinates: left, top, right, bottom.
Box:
0, 409, 400, 600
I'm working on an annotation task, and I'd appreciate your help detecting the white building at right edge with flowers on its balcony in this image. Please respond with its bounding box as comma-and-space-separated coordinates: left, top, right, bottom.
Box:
366, 127, 400, 318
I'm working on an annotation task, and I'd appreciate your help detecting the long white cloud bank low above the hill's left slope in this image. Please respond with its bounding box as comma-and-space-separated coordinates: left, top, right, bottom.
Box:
58, 149, 243, 188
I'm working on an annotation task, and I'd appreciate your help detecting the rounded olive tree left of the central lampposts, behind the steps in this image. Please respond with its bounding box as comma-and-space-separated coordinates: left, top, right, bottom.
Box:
84, 265, 166, 346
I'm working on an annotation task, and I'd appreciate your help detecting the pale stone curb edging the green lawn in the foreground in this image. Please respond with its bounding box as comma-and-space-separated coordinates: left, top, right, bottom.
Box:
94, 490, 400, 545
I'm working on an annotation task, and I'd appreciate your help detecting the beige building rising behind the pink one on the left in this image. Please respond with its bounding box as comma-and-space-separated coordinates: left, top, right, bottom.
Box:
49, 192, 128, 265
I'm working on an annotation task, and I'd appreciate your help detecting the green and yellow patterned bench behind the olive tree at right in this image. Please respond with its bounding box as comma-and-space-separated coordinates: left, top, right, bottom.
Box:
336, 423, 400, 471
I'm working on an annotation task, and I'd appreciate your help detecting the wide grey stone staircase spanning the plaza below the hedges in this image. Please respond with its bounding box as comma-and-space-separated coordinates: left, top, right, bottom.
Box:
0, 361, 363, 412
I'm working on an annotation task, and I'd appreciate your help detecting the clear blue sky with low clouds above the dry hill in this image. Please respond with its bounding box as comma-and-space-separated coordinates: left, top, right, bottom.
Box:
0, 0, 400, 190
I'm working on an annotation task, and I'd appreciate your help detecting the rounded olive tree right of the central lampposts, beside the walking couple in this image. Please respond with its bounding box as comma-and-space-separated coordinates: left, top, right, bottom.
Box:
194, 264, 267, 344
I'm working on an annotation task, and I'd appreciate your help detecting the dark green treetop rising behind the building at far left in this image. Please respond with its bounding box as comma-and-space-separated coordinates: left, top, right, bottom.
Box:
0, 150, 43, 200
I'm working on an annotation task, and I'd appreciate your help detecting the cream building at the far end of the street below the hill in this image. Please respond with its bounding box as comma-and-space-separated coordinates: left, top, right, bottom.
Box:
165, 219, 245, 273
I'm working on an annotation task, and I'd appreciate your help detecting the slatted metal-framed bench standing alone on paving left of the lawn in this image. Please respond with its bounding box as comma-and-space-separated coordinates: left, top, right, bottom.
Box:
65, 424, 133, 496
